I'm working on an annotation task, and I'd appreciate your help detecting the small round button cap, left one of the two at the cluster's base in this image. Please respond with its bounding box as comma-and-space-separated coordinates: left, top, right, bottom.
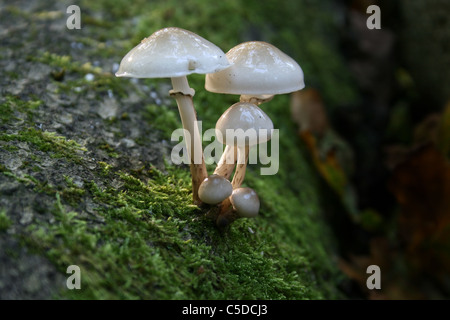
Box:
198, 174, 233, 204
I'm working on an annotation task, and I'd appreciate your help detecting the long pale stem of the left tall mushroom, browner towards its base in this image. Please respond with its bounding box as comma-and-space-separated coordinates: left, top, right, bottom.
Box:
170, 76, 208, 205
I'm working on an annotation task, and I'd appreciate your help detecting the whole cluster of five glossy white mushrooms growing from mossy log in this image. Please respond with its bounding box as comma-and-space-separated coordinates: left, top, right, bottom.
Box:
116, 28, 305, 225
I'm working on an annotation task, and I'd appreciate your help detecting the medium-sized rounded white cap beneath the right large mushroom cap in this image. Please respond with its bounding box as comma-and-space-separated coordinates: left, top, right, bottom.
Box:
216, 102, 273, 147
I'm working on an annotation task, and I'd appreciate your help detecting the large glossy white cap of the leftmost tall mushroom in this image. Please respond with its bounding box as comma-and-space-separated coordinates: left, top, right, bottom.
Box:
116, 27, 230, 78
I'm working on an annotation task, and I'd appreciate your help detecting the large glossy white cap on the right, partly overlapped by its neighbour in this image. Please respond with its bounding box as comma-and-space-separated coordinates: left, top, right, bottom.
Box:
205, 41, 305, 95
